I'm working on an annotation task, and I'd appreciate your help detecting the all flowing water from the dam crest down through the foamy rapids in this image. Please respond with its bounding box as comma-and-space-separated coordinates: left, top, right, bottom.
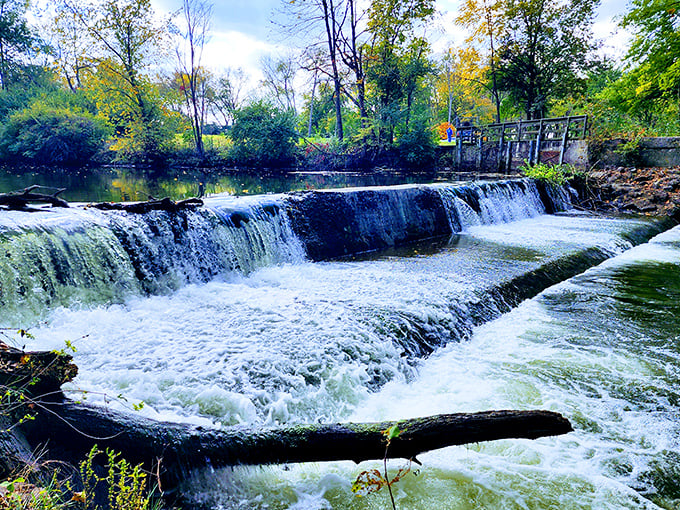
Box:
0, 181, 680, 510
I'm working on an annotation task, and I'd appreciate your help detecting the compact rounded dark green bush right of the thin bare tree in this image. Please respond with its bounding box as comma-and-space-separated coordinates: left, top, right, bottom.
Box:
230, 101, 298, 167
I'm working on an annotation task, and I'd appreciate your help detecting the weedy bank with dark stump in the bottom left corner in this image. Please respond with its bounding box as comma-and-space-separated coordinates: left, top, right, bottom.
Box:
0, 328, 153, 510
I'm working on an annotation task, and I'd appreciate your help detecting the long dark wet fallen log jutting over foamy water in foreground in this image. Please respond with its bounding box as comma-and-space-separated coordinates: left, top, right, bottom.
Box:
27, 400, 572, 489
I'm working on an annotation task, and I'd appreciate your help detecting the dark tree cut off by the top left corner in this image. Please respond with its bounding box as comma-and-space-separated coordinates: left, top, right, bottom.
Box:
0, 0, 37, 90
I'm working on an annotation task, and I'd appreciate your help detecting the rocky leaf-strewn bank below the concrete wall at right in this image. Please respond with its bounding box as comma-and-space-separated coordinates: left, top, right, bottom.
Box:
582, 166, 680, 220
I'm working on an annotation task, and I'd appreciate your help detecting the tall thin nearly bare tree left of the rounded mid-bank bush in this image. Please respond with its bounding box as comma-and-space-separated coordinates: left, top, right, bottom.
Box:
175, 0, 212, 158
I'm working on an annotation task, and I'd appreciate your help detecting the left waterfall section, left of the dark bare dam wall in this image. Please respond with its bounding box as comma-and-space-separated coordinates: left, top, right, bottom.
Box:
0, 199, 304, 323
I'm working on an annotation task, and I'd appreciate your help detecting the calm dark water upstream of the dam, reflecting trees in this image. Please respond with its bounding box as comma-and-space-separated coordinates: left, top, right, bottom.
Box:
0, 167, 474, 202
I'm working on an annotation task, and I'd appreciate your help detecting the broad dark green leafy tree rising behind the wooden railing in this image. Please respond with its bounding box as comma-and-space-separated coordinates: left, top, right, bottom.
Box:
497, 0, 599, 119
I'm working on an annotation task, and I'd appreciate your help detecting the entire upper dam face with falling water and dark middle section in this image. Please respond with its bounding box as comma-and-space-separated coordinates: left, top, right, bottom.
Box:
0, 180, 564, 321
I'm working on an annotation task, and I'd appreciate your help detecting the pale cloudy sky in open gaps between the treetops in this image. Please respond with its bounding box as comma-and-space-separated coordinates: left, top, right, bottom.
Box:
152, 0, 629, 88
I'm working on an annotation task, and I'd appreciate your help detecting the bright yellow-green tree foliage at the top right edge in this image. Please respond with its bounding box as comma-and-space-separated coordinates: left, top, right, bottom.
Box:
622, 0, 680, 121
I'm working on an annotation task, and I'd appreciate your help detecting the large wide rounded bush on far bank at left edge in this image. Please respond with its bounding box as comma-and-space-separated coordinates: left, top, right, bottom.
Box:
0, 103, 108, 166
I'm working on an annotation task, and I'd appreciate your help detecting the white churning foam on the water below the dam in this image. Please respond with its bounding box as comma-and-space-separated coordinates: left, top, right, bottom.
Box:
15, 216, 676, 509
